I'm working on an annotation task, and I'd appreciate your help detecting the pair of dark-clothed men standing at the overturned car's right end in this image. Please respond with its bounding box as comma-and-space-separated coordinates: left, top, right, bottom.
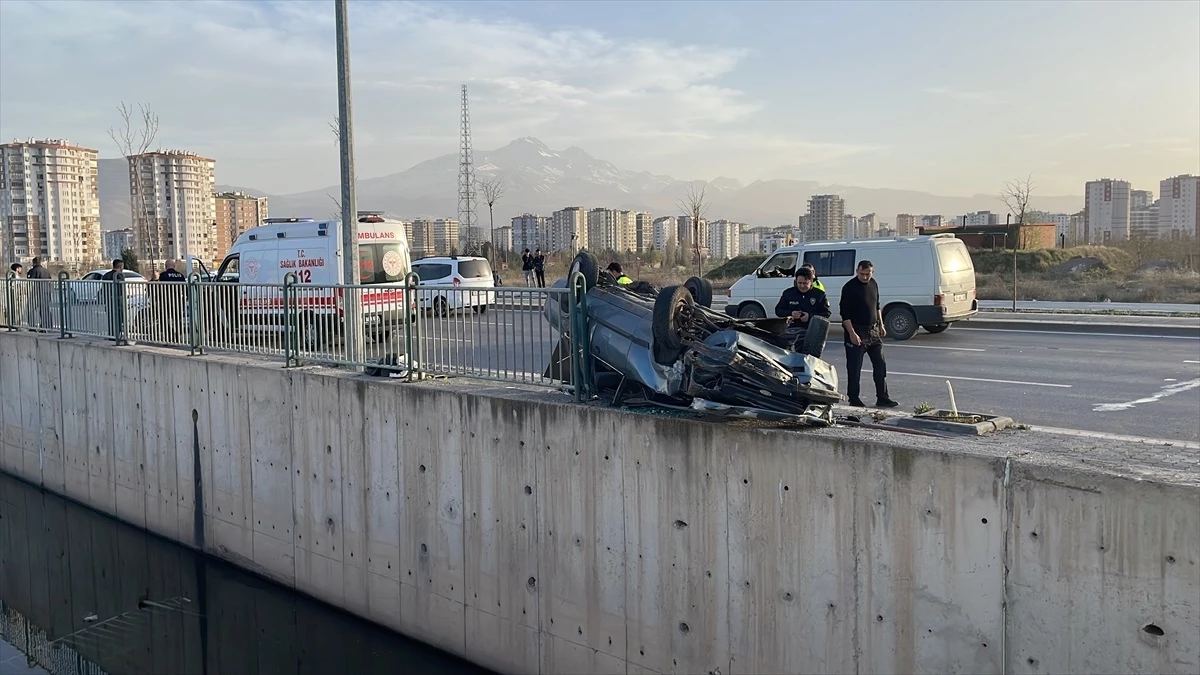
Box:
775, 261, 900, 408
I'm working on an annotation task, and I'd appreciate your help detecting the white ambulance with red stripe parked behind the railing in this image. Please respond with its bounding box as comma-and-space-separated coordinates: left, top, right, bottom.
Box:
204, 211, 416, 348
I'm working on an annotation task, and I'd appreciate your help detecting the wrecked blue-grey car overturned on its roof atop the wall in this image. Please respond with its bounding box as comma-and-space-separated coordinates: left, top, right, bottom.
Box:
545, 252, 841, 425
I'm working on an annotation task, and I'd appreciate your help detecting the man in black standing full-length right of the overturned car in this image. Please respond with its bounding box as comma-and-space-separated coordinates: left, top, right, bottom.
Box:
839, 261, 900, 408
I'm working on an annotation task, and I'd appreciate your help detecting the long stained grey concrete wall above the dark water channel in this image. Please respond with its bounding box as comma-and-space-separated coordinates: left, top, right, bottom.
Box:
0, 334, 1200, 674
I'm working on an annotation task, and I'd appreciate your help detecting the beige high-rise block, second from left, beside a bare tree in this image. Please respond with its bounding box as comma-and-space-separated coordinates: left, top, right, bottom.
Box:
128, 150, 217, 267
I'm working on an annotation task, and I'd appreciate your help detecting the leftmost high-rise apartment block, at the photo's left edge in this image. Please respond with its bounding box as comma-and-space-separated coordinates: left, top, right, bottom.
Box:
0, 138, 101, 263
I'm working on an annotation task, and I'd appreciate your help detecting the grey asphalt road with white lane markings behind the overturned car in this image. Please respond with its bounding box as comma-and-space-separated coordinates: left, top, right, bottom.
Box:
398, 305, 1200, 442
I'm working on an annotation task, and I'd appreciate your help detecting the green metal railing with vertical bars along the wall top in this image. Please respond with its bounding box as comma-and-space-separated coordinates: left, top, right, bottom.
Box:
0, 269, 590, 400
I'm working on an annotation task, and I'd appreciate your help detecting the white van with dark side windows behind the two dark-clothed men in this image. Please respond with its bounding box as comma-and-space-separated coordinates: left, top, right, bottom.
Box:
725, 233, 979, 340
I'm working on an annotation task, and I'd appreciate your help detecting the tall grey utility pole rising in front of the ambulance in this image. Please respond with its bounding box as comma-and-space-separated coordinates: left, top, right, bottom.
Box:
335, 0, 364, 363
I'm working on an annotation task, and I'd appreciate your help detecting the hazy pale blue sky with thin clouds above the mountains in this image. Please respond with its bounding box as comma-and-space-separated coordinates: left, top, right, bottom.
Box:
0, 0, 1200, 195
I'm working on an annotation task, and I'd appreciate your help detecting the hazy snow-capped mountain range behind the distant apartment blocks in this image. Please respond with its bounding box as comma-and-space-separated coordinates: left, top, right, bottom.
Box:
100, 138, 1084, 229
